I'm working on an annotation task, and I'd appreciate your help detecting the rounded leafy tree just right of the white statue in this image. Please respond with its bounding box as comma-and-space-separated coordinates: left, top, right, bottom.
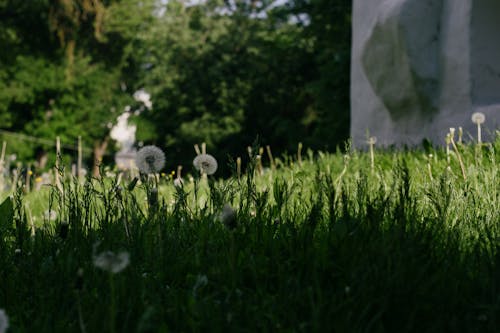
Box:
131, 1, 313, 171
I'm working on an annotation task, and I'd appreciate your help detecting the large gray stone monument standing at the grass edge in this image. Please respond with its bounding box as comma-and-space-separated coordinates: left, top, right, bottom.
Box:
351, 0, 500, 146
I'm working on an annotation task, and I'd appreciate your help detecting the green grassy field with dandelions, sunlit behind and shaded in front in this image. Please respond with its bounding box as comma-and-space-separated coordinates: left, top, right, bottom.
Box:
0, 138, 500, 333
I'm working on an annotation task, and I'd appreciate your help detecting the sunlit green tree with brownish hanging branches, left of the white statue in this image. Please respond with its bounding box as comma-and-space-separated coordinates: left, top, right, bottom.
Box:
0, 0, 152, 174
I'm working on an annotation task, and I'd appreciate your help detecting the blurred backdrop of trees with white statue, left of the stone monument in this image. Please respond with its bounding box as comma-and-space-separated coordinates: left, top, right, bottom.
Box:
0, 0, 352, 175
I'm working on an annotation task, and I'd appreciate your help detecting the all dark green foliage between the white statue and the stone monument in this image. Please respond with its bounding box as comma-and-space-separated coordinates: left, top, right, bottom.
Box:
131, 1, 350, 170
